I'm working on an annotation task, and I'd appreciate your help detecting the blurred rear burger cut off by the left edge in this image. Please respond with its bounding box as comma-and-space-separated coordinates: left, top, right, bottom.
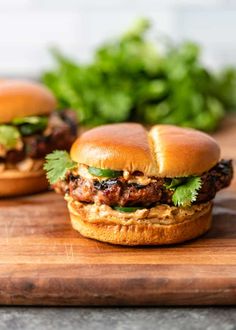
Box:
0, 80, 77, 197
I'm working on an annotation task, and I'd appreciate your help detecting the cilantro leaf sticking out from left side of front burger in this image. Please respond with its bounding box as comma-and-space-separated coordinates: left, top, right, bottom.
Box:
44, 150, 77, 184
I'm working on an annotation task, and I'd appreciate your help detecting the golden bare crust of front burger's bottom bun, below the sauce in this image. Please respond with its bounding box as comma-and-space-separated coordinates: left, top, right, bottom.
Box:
68, 199, 212, 246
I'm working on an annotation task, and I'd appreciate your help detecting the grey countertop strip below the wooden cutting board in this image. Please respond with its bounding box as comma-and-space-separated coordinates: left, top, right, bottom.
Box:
0, 307, 236, 330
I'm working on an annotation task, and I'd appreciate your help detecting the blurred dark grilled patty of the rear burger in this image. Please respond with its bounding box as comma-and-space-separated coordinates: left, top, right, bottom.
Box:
0, 110, 77, 164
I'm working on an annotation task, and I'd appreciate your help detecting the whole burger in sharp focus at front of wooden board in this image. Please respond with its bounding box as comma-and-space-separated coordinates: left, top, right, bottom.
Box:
45, 123, 233, 245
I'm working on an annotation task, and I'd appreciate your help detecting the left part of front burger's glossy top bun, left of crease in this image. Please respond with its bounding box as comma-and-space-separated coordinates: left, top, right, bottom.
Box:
71, 123, 156, 175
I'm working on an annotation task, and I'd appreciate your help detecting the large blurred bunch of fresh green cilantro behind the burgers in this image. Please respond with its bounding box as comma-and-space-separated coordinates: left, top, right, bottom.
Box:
42, 19, 236, 131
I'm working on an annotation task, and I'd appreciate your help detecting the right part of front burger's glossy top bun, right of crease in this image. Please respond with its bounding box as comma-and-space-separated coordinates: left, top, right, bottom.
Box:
149, 125, 220, 177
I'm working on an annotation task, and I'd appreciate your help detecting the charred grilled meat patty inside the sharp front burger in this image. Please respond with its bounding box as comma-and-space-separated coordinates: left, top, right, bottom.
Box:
55, 160, 233, 206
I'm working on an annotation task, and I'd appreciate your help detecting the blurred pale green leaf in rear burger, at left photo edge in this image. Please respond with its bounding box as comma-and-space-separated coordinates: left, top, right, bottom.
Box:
0, 125, 20, 150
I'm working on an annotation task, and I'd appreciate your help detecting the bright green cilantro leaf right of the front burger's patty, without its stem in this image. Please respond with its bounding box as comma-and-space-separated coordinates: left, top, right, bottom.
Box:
172, 177, 202, 206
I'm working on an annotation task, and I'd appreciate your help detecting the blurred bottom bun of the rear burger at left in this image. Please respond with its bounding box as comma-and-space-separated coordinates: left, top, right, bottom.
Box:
0, 170, 48, 197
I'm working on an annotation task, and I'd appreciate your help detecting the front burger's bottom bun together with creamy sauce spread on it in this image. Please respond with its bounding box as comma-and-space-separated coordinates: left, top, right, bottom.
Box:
68, 200, 212, 245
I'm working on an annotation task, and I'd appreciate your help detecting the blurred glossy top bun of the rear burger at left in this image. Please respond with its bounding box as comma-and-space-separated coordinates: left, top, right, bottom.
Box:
0, 79, 57, 124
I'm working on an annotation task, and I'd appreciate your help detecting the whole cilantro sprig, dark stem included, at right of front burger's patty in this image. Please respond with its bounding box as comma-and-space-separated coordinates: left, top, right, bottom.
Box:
165, 176, 202, 207
